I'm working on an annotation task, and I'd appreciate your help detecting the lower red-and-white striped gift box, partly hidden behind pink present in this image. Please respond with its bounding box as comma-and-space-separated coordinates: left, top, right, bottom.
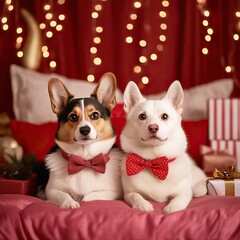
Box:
210, 140, 240, 171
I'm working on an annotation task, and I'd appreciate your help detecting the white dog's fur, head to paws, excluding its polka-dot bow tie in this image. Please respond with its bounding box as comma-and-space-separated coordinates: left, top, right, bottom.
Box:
120, 81, 207, 213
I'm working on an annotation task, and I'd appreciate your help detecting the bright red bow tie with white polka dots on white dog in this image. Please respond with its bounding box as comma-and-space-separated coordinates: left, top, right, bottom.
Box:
126, 154, 175, 180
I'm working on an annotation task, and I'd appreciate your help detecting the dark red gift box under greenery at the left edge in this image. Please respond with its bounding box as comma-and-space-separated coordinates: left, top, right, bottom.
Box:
0, 174, 36, 195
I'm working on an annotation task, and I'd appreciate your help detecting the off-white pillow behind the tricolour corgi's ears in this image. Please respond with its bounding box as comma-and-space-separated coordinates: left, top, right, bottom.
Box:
10, 65, 123, 124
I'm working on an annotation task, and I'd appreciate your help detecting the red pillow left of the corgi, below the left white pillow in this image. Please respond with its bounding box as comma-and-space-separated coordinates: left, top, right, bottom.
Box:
11, 120, 58, 161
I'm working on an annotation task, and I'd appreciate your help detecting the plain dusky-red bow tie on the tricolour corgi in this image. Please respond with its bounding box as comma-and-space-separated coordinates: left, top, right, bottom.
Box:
62, 152, 110, 175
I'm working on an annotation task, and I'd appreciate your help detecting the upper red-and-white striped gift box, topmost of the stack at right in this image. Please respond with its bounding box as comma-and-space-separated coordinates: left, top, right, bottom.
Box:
208, 98, 240, 140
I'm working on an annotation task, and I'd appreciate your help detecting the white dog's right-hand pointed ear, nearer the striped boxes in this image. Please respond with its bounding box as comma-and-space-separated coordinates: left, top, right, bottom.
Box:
164, 80, 184, 114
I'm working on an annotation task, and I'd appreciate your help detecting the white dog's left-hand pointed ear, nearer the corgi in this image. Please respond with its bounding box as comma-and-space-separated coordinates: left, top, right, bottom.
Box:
123, 81, 145, 113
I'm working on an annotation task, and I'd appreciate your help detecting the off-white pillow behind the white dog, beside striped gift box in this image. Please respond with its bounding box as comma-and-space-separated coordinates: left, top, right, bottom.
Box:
145, 79, 233, 121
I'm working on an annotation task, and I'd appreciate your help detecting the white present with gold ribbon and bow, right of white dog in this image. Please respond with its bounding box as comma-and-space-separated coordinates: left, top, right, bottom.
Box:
207, 166, 240, 196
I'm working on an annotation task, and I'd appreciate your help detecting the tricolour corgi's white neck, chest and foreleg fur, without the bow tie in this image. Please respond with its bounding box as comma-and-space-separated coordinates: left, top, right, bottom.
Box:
46, 138, 123, 208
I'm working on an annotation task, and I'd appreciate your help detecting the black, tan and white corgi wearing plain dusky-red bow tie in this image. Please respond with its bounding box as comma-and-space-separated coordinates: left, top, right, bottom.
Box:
45, 73, 123, 208
